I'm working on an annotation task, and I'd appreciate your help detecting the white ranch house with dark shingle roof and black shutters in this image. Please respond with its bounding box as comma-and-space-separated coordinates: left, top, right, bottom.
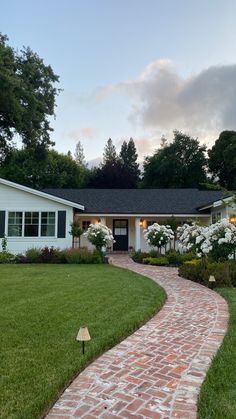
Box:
0, 178, 236, 253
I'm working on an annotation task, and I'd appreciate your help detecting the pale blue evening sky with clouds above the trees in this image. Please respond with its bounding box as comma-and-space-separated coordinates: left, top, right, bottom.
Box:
0, 0, 236, 162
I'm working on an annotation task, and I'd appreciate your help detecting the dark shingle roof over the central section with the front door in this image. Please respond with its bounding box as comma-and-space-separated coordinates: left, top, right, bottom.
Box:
43, 189, 227, 215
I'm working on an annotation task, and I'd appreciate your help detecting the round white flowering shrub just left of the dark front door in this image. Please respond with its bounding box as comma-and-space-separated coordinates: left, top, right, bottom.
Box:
84, 224, 115, 251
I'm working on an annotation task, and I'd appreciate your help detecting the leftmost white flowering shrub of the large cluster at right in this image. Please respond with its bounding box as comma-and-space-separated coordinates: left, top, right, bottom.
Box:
177, 223, 202, 252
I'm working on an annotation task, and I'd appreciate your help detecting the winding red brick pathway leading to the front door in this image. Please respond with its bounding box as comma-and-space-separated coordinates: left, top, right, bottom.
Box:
47, 255, 228, 419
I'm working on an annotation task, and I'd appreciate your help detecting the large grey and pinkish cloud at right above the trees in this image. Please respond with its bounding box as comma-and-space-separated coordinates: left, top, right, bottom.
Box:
97, 60, 236, 138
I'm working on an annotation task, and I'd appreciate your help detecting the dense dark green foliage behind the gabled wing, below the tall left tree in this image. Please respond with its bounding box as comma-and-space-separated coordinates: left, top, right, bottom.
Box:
0, 149, 88, 188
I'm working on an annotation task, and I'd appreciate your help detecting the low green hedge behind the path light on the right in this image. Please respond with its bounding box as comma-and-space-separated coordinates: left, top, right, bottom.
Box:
179, 260, 236, 287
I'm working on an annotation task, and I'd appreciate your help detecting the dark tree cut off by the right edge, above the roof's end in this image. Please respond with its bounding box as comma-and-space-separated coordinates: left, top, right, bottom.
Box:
208, 131, 236, 189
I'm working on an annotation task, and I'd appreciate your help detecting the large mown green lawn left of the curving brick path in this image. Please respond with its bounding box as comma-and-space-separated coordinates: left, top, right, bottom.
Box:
0, 265, 166, 419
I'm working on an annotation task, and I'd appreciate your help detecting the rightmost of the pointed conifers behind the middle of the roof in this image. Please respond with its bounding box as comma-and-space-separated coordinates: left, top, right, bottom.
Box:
120, 138, 140, 188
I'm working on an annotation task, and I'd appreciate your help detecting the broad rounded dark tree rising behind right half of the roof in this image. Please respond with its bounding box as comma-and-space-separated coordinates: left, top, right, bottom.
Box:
143, 131, 206, 188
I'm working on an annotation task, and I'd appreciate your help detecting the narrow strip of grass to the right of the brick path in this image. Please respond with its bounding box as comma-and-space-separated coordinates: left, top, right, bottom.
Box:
199, 288, 236, 419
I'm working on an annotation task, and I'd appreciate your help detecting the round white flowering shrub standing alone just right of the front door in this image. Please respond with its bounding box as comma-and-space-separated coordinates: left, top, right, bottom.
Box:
144, 223, 174, 248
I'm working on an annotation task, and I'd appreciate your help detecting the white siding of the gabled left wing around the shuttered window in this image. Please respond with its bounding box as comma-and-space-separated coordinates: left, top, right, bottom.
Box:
0, 184, 73, 253
